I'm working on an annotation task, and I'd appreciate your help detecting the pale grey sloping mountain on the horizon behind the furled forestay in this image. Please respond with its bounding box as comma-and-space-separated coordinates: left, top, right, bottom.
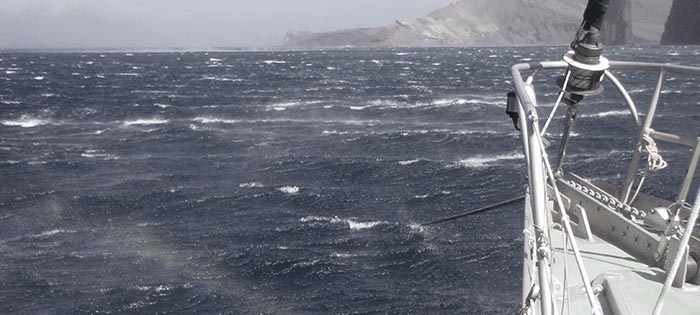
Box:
284, 0, 672, 48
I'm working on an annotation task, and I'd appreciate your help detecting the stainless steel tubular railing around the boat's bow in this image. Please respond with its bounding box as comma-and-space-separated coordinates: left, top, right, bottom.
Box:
511, 61, 700, 315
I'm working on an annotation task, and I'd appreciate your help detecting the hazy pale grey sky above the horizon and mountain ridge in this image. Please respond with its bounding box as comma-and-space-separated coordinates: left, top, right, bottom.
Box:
0, 0, 456, 49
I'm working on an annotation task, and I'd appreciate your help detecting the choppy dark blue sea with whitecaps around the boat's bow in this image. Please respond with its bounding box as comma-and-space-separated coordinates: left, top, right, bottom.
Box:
0, 46, 700, 314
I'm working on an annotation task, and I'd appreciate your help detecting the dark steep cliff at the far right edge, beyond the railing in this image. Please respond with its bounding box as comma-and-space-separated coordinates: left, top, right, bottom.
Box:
661, 0, 700, 45
